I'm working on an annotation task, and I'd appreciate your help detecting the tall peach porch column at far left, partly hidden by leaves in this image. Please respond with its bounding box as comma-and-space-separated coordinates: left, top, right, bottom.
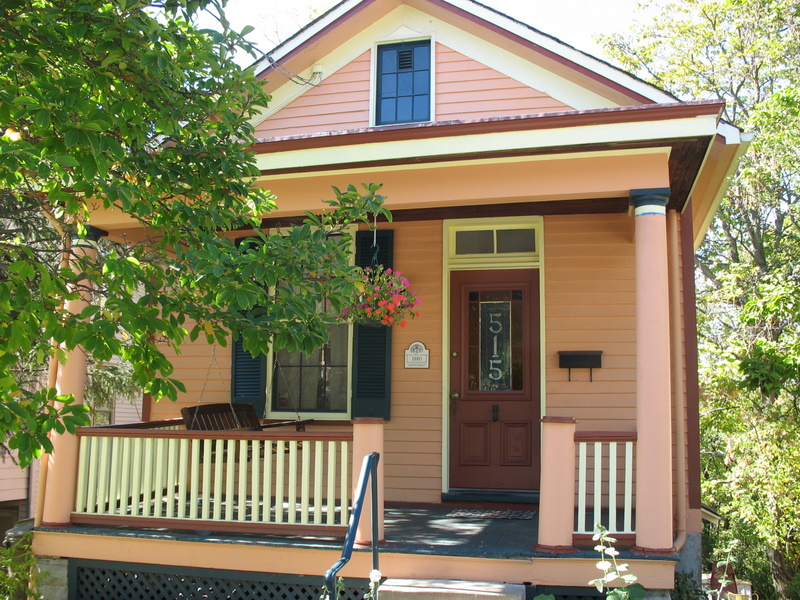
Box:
40, 226, 106, 527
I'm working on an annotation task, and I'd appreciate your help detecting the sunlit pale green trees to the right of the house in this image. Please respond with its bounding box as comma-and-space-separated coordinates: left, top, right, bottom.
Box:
606, 0, 800, 598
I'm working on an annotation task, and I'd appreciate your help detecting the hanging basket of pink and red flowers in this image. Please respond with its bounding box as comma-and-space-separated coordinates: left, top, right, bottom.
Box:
342, 265, 420, 327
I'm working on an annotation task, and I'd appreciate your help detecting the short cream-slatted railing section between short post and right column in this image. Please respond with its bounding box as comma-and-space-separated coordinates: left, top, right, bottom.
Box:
575, 432, 636, 534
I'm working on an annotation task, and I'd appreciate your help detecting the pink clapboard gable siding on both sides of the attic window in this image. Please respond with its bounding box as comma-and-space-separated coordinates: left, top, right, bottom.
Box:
256, 44, 571, 138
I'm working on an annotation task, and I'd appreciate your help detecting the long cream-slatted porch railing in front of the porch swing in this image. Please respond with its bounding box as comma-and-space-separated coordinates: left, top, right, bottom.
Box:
72, 422, 352, 533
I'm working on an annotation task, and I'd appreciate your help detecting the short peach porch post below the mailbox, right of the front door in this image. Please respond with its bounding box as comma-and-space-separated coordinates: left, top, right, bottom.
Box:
534, 417, 578, 554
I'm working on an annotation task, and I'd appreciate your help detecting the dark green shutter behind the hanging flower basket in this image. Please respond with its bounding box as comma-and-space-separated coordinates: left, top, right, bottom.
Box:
351, 230, 394, 421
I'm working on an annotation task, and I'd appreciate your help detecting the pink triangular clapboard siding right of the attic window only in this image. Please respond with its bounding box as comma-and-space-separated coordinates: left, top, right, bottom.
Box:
436, 44, 571, 121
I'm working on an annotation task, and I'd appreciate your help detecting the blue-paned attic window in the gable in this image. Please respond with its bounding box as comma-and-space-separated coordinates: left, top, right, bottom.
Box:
375, 40, 431, 125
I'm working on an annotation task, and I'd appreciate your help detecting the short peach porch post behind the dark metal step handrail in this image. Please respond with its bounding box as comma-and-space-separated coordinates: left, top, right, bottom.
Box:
353, 417, 386, 546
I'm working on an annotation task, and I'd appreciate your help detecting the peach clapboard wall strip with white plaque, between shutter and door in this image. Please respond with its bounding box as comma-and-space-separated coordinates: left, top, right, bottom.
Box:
385, 221, 442, 502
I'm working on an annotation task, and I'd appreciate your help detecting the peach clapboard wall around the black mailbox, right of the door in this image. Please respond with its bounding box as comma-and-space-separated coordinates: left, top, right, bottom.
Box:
544, 215, 636, 431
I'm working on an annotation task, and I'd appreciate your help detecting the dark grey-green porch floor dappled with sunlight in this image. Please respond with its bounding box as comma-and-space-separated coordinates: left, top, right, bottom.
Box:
50, 506, 596, 559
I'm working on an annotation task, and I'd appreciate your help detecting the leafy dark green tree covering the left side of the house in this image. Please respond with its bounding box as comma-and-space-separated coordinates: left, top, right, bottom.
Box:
0, 0, 386, 466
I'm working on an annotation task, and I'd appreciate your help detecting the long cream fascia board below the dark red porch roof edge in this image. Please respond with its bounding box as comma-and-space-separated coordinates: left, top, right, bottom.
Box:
256, 115, 717, 172
